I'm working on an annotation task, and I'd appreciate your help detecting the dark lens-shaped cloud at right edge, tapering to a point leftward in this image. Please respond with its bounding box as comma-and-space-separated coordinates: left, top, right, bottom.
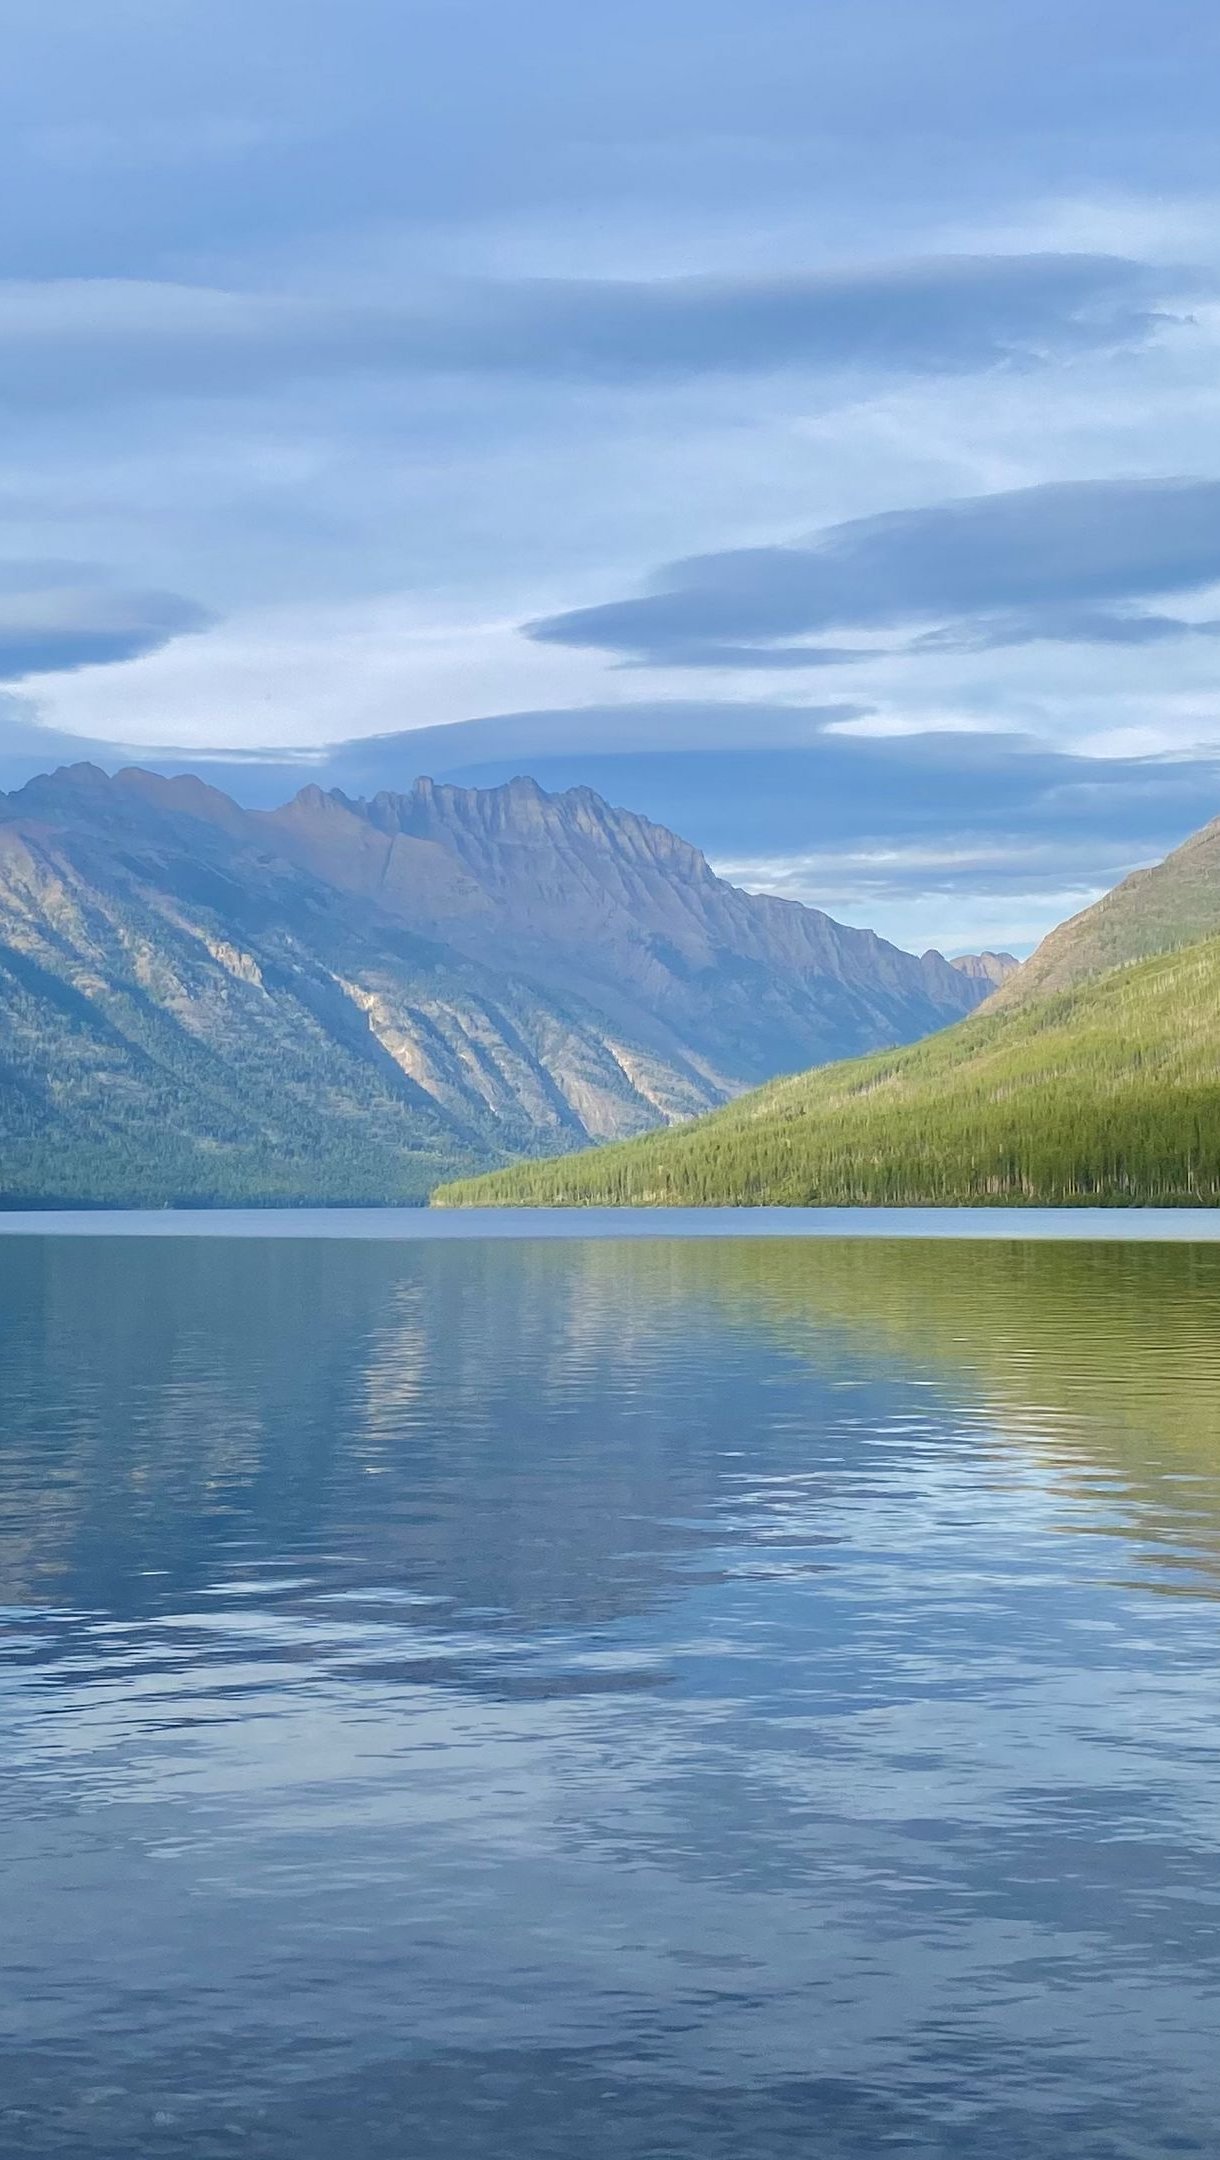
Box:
527, 480, 1220, 667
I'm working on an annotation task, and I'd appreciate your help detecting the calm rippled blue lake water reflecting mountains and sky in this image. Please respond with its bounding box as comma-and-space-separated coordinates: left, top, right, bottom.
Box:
0, 1225, 1220, 2160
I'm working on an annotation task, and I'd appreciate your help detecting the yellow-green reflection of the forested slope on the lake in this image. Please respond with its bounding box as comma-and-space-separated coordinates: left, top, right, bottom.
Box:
617, 1238, 1220, 1589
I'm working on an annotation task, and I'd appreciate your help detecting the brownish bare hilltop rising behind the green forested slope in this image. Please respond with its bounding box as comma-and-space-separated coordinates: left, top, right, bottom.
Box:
998, 819, 1220, 1004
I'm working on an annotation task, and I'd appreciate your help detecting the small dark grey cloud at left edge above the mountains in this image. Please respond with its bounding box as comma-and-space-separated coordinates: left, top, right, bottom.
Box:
0, 562, 212, 683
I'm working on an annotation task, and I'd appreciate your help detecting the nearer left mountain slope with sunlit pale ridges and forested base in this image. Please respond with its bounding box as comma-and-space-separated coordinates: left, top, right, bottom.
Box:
0, 773, 715, 1205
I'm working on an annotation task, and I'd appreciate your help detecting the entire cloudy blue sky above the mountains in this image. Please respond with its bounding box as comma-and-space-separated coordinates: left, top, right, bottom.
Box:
0, 0, 1220, 950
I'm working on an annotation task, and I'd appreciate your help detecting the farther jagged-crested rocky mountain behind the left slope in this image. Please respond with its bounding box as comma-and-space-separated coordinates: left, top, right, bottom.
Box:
266, 780, 1002, 1099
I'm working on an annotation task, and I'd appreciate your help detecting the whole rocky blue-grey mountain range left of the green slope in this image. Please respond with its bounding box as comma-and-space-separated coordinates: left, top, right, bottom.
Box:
0, 765, 997, 1205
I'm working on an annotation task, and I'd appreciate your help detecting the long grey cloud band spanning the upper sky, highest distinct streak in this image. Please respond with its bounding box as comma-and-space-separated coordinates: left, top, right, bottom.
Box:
0, 253, 1201, 406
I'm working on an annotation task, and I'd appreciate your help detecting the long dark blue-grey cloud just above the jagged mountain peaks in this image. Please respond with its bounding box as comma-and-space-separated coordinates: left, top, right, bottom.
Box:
388, 700, 1220, 862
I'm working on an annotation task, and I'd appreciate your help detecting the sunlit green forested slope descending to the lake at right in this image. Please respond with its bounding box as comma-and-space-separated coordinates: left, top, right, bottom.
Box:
434, 937, 1220, 1207
